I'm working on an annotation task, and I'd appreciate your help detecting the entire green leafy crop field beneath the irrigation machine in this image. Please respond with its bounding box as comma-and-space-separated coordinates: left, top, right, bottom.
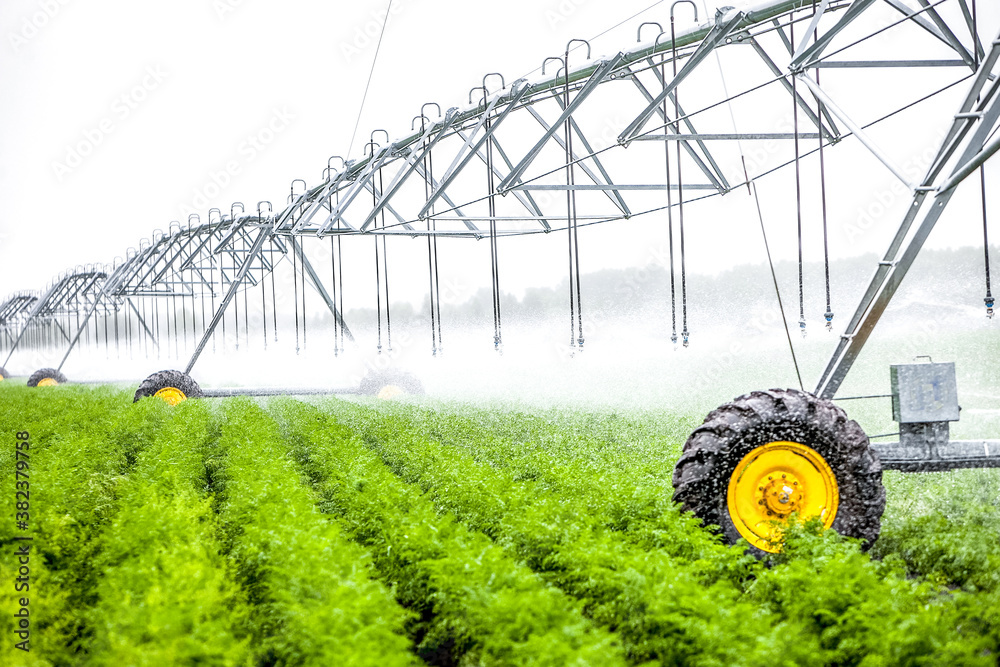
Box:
0, 382, 1000, 666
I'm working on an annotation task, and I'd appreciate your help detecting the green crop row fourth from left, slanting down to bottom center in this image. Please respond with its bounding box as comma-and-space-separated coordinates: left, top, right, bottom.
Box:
272, 401, 621, 665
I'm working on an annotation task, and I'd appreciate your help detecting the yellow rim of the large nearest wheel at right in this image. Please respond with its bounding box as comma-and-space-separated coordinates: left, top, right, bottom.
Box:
726, 441, 839, 553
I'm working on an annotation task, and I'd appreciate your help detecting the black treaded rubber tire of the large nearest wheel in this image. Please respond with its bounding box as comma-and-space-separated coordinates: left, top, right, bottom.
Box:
673, 389, 885, 557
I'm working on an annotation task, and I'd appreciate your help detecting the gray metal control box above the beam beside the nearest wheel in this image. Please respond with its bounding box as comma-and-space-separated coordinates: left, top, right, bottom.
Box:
889, 362, 958, 424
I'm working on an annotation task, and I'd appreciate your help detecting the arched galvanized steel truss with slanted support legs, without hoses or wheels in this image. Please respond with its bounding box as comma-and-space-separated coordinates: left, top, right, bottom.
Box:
0, 0, 1000, 396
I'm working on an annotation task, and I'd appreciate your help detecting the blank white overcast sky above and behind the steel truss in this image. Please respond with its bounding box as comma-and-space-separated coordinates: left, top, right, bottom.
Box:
0, 0, 997, 308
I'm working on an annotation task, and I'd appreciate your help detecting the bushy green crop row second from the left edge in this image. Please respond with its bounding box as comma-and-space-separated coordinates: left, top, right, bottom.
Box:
84, 402, 248, 665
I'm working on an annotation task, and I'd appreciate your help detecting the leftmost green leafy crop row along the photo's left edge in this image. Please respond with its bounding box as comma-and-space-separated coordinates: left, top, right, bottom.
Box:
0, 388, 167, 665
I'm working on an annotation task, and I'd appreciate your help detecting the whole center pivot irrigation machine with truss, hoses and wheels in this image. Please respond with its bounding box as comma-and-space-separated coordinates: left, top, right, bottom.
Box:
0, 0, 1000, 551
